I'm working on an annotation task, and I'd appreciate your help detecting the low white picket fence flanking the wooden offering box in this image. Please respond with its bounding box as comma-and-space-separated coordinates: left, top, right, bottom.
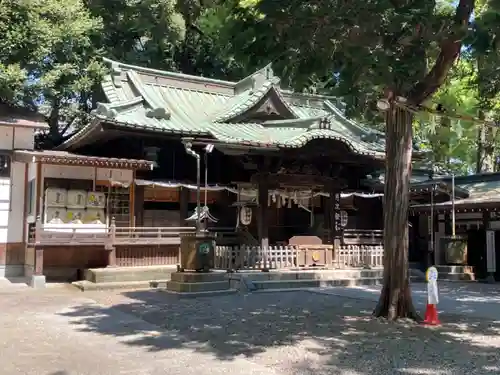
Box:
215, 245, 384, 270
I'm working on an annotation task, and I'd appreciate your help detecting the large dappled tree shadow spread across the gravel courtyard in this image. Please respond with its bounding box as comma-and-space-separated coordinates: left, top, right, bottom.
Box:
60, 291, 500, 375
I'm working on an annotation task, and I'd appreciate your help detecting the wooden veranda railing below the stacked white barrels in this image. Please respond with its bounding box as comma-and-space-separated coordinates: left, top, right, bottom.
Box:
28, 220, 196, 248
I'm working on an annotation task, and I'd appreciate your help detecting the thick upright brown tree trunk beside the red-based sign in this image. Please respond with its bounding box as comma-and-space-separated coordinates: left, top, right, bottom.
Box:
373, 105, 420, 320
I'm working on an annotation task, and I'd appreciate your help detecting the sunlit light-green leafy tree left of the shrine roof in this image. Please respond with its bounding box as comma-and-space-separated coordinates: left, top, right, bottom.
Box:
0, 0, 103, 145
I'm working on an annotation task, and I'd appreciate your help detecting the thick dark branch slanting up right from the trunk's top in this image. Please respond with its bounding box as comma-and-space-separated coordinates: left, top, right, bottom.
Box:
408, 0, 475, 104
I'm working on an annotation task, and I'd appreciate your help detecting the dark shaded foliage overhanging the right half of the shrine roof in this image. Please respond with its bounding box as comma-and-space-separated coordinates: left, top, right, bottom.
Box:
217, 0, 467, 108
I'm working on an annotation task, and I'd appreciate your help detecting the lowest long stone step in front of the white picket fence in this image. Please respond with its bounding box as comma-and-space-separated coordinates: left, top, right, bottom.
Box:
253, 277, 382, 291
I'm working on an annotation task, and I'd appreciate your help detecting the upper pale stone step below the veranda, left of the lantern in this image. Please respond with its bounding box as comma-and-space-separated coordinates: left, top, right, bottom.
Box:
85, 265, 177, 284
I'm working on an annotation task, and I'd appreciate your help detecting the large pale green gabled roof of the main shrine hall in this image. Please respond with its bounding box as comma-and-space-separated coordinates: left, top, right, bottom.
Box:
59, 59, 385, 159
